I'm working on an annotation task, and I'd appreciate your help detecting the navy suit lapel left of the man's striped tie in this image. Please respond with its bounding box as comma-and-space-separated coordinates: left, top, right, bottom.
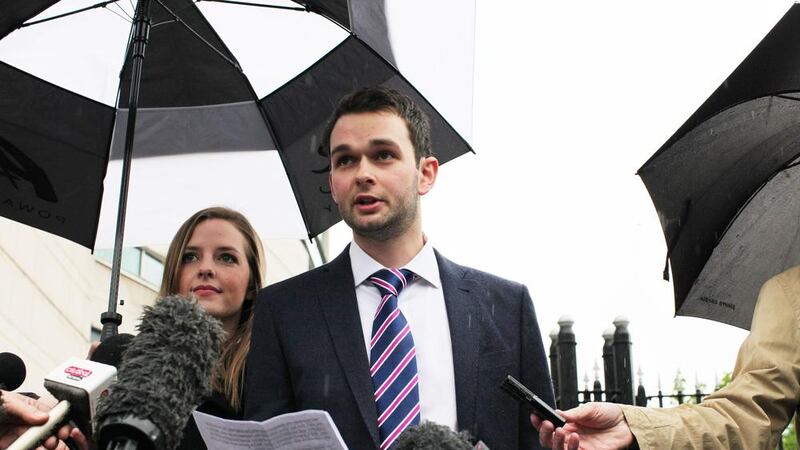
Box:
317, 250, 379, 446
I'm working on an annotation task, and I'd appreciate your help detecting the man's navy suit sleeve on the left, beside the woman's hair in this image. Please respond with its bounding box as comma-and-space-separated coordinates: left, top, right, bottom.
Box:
244, 290, 295, 421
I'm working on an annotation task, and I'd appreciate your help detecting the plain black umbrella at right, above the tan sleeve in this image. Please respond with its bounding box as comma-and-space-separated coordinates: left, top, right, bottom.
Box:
638, 4, 800, 329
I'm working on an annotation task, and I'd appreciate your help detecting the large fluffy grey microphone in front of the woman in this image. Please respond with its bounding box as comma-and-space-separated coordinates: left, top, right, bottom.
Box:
95, 296, 224, 450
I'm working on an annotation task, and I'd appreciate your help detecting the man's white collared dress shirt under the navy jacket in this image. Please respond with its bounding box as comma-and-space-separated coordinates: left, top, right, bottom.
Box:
350, 242, 458, 430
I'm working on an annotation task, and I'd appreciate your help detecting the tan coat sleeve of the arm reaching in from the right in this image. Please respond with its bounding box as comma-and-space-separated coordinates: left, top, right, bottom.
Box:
623, 267, 800, 450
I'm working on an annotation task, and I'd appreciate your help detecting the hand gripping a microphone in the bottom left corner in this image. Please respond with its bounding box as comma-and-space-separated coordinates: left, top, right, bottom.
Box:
0, 391, 89, 450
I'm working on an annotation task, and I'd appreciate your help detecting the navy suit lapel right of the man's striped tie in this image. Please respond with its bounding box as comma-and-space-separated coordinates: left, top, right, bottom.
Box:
436, 252, 480, 436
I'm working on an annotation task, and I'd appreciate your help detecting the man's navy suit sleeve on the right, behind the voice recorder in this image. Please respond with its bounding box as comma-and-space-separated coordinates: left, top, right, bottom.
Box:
519, 286, 555, 449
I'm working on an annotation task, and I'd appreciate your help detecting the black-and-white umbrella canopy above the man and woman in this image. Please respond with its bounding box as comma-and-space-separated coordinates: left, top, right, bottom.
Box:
0, 0, 474, 248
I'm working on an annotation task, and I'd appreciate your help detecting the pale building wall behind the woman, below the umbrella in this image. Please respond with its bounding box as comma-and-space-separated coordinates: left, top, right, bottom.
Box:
0, 217, 324, 393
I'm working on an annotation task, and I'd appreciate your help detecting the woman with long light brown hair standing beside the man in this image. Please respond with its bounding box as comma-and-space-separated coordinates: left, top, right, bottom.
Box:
159, 207, 263, 450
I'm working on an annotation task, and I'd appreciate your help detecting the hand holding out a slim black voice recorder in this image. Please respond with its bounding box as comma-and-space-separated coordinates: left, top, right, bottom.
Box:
531, 403, 633, 450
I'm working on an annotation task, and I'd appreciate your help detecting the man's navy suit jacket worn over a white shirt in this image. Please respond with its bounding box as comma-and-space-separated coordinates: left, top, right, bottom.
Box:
244, 249, 554, 450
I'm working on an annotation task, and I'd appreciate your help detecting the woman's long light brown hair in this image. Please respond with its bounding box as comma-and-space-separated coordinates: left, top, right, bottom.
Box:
159, 206, 264, 412
